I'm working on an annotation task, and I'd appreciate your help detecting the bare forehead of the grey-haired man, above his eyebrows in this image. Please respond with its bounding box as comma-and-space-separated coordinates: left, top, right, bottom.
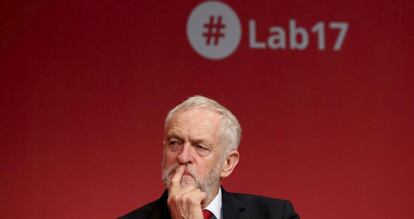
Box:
166, 108, 221, 137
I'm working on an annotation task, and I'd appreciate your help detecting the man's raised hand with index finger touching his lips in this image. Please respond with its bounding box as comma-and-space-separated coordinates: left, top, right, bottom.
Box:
167, 166, 207, 219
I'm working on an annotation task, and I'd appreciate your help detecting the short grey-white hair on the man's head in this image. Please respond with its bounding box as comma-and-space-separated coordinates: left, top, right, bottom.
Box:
164, 96, 241, 154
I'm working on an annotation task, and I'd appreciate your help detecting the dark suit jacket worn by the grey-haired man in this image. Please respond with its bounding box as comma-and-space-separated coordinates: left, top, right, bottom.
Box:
120, 188, 300, 219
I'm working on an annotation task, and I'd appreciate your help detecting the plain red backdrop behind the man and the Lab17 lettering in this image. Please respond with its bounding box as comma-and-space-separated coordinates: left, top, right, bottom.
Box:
0, 0, 414, 219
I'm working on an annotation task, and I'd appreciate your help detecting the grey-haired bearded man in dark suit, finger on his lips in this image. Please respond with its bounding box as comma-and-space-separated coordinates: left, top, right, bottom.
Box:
121, 96, 299, 219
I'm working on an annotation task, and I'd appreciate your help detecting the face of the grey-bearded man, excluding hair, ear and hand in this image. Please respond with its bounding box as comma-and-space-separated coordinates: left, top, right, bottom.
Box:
163, 108, 224, 194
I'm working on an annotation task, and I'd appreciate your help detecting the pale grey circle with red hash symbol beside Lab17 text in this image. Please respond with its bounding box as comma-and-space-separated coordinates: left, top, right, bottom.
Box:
187, 1, 241, 59
